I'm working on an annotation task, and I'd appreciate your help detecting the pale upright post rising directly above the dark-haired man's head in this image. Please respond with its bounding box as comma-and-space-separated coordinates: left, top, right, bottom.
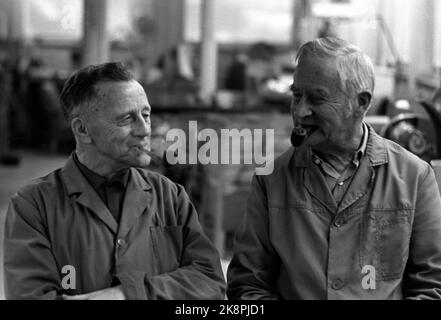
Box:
83, 0, 109, 65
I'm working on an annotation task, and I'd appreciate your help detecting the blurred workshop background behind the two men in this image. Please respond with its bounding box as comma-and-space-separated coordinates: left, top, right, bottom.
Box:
0, 0, 441, 298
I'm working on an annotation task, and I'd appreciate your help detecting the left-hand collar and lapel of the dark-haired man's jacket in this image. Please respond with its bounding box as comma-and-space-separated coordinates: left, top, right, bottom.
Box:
61, 156, 118, 235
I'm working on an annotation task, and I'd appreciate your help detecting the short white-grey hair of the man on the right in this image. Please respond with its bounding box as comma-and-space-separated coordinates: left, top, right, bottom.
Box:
296, 37, 375, 96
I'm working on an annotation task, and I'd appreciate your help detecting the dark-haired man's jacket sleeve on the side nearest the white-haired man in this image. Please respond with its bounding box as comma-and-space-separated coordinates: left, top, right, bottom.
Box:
116, 185, 226, 300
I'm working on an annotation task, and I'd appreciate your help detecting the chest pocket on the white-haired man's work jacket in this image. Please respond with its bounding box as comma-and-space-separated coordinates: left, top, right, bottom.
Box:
360, 209, 412, 281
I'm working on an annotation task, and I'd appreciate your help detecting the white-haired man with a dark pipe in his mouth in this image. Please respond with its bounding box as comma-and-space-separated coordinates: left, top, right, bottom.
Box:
227, 38, 441, 299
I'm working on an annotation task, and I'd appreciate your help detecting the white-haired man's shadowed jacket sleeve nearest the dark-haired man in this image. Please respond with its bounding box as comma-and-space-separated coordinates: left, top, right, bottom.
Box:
227, 175, 280, 300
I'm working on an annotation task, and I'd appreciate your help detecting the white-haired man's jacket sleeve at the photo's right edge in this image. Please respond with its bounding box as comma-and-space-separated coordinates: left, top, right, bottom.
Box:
403, 165, 441, 299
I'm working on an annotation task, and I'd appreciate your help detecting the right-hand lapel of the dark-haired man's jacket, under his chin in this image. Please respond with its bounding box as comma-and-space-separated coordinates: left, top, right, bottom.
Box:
118, 168, 153, 238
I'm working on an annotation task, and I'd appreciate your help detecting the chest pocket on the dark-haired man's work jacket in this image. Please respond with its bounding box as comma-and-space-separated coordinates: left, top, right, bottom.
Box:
150, 226, 183, 273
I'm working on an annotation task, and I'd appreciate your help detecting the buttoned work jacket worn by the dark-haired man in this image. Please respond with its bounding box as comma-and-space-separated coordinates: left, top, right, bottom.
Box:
4, 158, 225, 299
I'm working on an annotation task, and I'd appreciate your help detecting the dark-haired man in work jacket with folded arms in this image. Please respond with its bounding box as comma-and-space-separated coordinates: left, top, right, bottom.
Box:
4, 63, 225, 300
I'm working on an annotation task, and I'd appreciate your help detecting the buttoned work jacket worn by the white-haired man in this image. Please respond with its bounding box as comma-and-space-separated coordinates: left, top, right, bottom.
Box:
227, 127, 441, 299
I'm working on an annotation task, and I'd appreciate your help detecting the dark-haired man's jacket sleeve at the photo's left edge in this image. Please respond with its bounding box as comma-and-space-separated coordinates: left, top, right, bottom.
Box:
3, 195, 61, 300
